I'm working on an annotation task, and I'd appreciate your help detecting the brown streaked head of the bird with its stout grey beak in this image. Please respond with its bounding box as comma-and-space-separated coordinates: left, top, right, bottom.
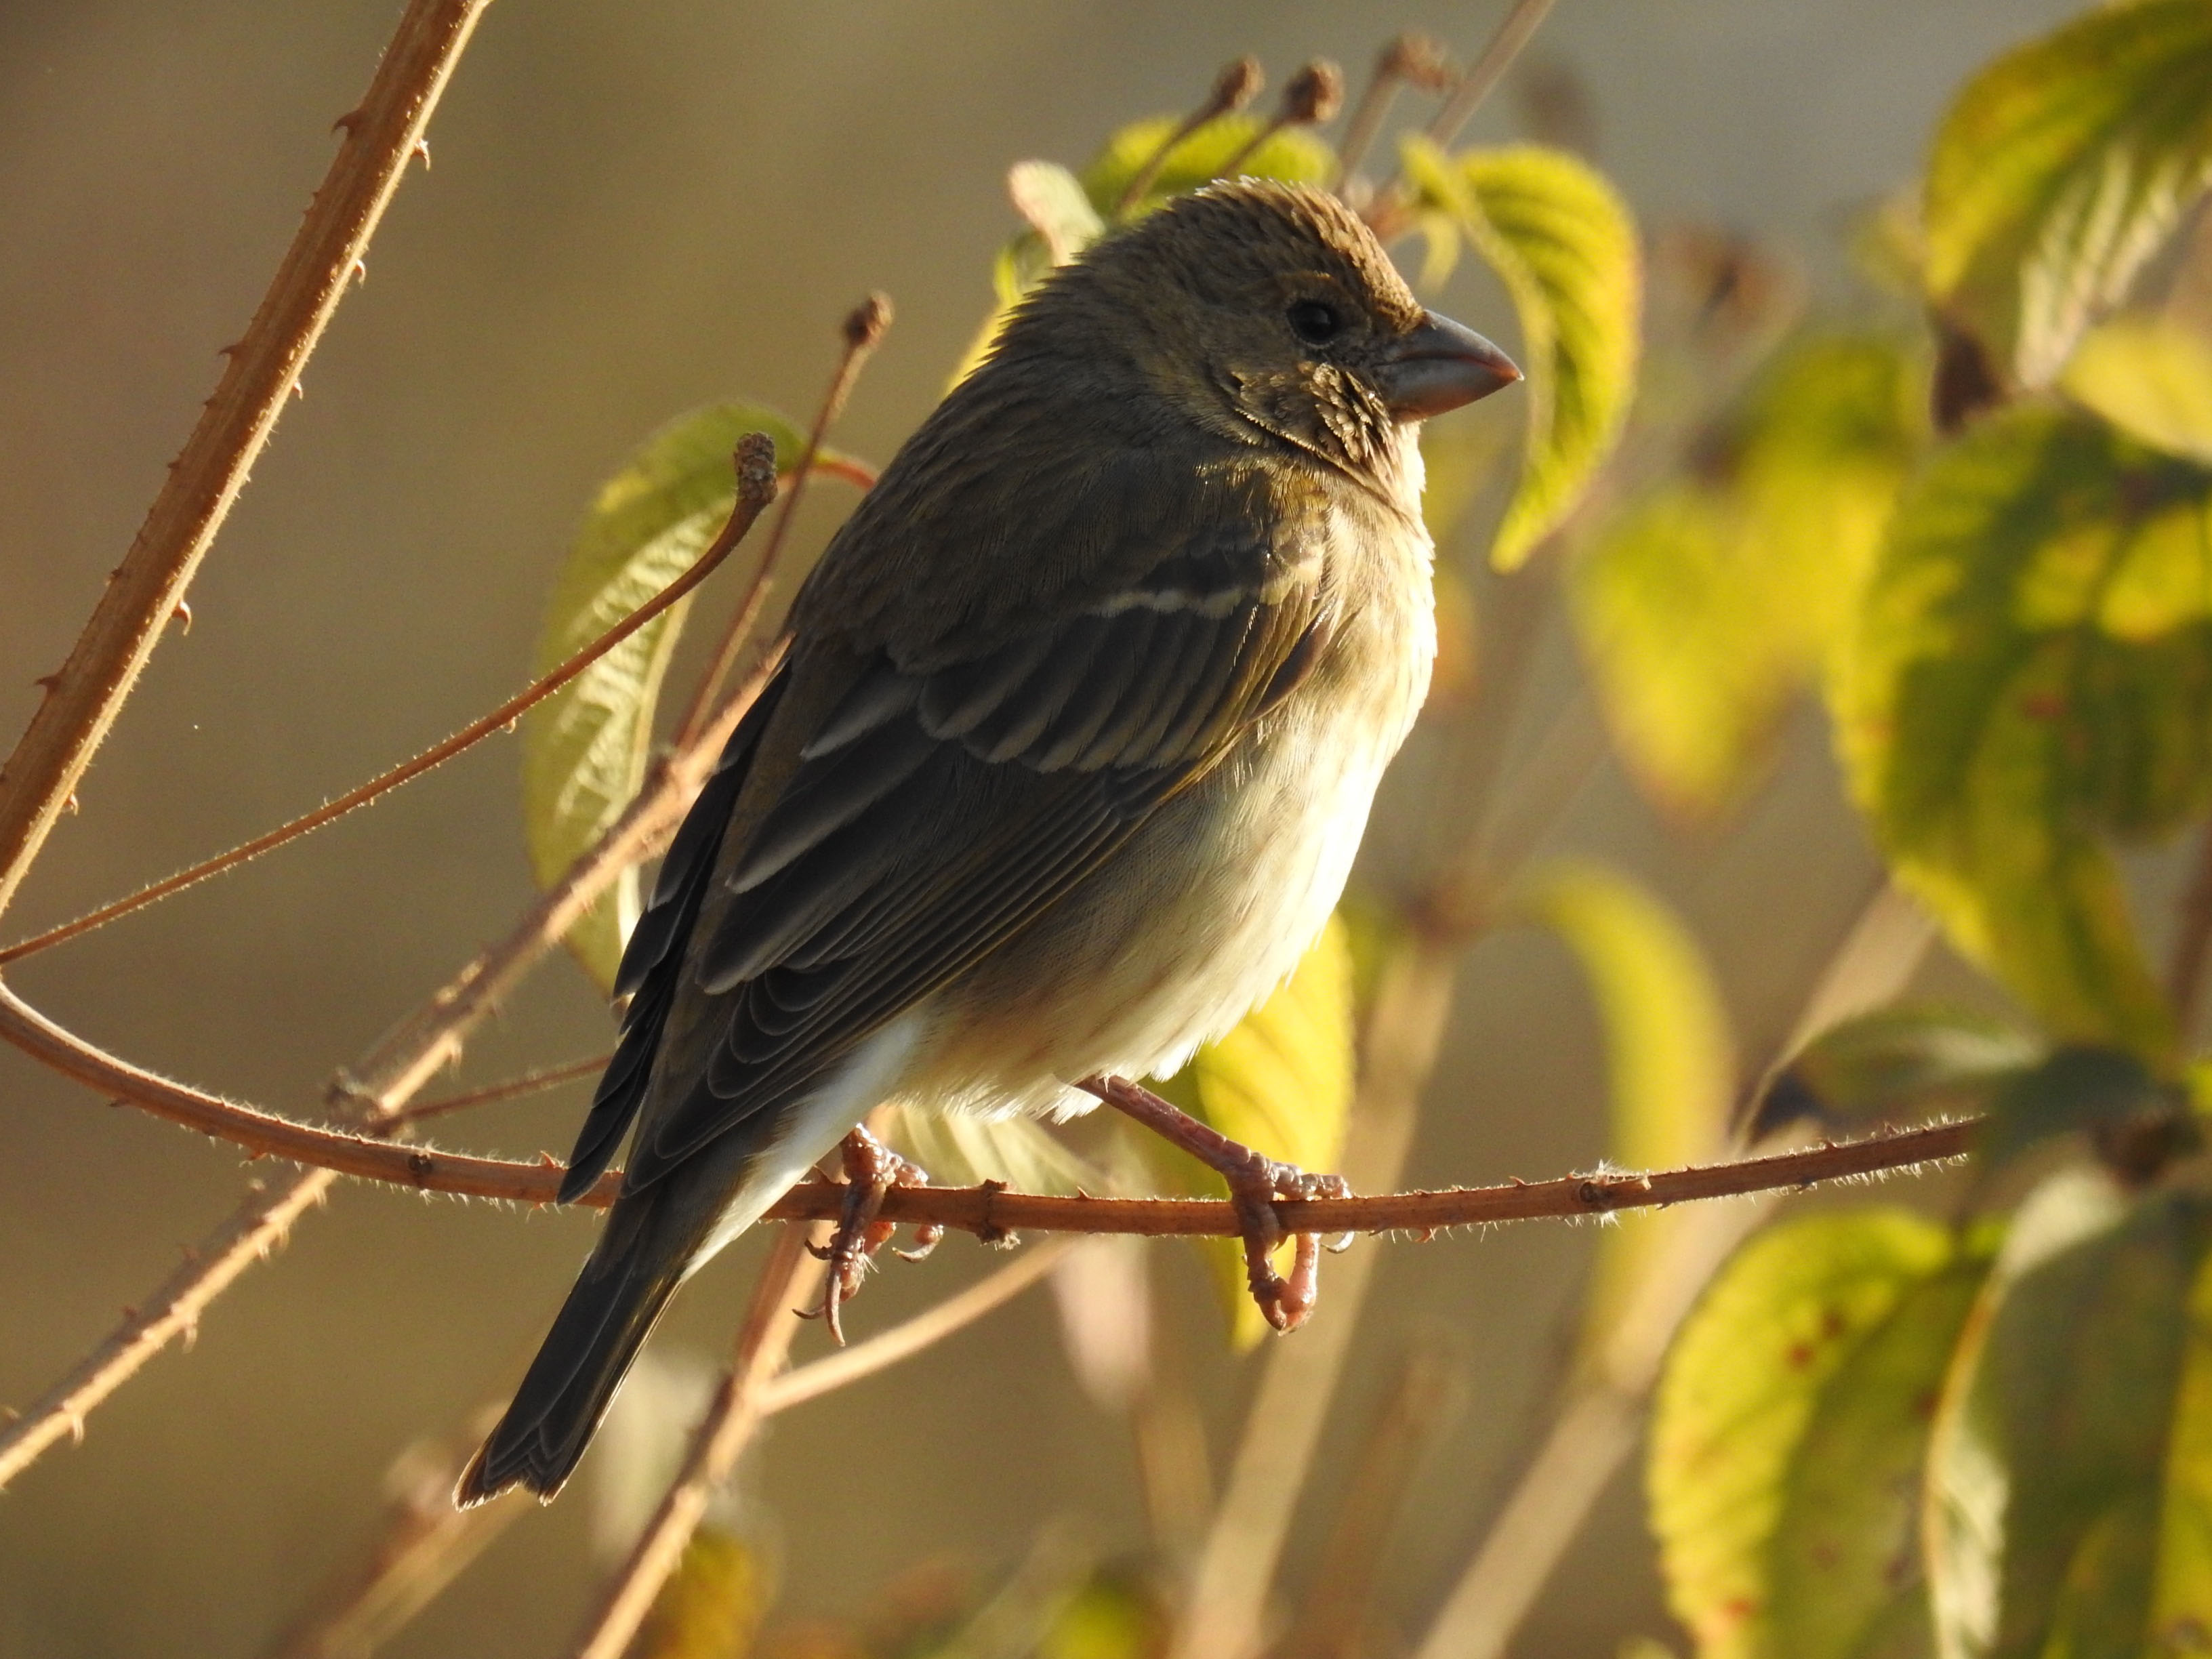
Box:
1040, 179, 1519, 493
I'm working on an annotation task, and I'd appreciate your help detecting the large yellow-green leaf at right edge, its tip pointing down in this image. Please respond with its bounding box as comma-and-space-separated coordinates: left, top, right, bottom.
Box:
1834, 405, 2212, 1073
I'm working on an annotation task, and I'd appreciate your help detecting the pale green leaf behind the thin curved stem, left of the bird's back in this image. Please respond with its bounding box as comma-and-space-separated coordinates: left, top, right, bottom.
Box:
522, 403, 832, 987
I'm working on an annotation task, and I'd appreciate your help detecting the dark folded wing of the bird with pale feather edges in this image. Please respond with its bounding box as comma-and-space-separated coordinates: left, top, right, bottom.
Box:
609, 484, 1332, 1190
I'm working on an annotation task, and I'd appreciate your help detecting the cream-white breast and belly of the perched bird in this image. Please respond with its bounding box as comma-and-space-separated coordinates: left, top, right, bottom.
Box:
911, 506, 1435, 1111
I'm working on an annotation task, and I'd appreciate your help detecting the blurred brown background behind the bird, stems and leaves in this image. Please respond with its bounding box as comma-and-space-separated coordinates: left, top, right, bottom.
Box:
0, 0, 2072, 1659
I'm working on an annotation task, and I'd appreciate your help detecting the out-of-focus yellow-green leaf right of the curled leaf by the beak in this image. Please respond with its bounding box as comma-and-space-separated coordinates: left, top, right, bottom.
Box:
1568, 334, 1927, 819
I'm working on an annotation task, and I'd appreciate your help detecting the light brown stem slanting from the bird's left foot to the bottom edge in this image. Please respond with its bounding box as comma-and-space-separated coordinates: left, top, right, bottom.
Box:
575, 1228, 825, 1659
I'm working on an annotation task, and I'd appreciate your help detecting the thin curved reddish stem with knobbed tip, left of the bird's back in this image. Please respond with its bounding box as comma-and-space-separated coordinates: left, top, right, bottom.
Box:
0, 431, 798, 966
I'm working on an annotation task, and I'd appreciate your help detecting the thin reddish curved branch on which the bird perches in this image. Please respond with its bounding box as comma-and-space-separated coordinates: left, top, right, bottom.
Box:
0, 968, 1982, 1239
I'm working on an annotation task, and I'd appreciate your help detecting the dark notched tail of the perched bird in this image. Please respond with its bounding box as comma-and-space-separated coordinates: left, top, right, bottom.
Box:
453, 1188, 701, 1509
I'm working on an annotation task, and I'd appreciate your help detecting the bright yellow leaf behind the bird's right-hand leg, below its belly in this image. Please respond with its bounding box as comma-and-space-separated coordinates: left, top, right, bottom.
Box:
1143, 916, 1354, 1349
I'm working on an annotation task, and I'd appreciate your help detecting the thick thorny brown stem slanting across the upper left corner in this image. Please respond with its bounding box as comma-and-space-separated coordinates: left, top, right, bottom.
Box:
0, 0, 489, 912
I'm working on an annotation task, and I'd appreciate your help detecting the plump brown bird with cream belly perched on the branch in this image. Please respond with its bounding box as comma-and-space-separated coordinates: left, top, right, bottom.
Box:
455, 179, 1519, 1507
